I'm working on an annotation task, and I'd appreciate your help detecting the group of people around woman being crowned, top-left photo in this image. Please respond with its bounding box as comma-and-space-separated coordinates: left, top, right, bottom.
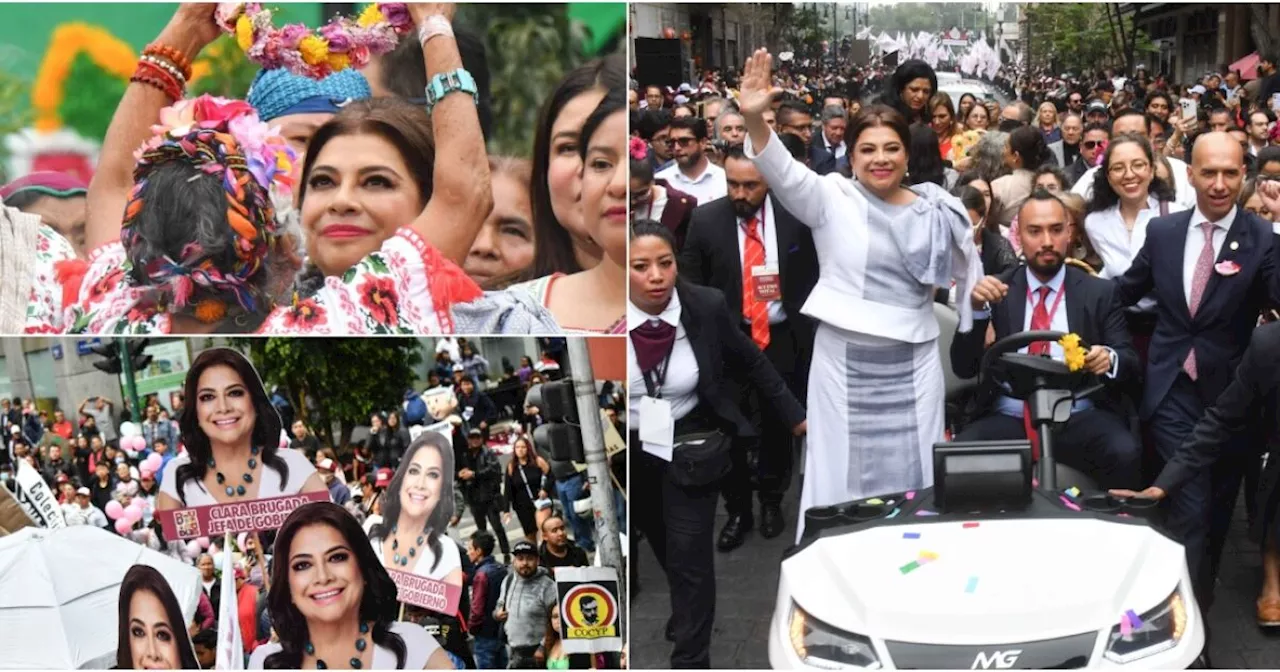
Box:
0, 4, 627, 335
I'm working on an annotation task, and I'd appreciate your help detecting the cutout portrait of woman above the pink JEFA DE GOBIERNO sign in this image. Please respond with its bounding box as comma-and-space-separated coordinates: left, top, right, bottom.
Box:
156, 348, 326, 511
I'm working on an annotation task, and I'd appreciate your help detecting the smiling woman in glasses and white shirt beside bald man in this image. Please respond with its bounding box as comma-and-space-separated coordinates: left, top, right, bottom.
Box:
1084, 133, 1185, 370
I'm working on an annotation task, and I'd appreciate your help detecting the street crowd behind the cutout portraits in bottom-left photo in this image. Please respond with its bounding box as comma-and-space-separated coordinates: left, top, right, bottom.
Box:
0, 338, 626, 669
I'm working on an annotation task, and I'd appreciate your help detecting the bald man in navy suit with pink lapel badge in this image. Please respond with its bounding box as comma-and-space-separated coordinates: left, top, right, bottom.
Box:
1115, 133, 1280, 611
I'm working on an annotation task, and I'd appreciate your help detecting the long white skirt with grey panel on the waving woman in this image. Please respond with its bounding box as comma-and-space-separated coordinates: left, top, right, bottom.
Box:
796, 323, 946, 543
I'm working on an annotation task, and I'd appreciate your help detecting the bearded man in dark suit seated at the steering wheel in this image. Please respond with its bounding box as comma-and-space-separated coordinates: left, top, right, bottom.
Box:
951, 191, 1142, 488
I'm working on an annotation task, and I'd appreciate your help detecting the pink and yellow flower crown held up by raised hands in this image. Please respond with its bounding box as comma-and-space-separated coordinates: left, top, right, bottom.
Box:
214, 3, 413, 79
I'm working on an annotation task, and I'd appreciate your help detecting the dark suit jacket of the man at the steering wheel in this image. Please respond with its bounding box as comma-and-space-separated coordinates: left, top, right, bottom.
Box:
951, 265, 1139, 411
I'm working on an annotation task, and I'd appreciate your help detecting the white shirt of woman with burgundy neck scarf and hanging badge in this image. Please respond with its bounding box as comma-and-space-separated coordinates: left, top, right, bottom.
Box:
627, 292, 698, 430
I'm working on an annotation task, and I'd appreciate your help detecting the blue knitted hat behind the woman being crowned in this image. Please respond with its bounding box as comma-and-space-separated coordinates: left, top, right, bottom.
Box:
247, 68, 374, 122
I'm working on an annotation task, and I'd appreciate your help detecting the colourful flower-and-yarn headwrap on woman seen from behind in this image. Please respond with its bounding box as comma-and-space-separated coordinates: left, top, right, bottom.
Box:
120, 96, 294, 321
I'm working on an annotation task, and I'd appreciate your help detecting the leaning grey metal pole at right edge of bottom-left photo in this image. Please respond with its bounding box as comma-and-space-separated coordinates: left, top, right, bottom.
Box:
568, 338, 627, 613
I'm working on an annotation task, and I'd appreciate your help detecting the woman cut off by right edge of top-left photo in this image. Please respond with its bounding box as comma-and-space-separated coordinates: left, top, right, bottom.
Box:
512, 88, 630, 334
